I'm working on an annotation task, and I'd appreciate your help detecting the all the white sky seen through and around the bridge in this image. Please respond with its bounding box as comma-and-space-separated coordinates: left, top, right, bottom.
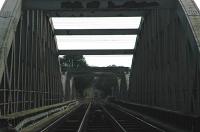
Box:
0, 0, 200, 67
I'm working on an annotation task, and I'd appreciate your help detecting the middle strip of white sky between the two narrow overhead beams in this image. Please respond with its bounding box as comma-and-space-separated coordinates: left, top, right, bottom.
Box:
56, 35, 137, 50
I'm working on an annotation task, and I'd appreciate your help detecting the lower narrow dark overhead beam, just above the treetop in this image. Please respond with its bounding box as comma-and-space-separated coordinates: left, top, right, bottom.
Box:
58, 49, 134, 55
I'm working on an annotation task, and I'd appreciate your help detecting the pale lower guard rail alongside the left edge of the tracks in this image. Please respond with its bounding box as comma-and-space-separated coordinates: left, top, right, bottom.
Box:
15, 101, 79, 131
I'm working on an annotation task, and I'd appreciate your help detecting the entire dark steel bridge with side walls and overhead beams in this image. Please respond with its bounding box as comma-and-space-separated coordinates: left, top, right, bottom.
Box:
0, 0, 200, 131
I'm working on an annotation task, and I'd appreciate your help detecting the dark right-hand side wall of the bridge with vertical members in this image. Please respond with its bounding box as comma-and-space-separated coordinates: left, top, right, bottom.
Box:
129, 0, 200, 114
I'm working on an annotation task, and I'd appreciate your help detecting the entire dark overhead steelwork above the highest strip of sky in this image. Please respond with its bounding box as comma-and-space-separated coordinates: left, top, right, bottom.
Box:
23, 0, 166, 17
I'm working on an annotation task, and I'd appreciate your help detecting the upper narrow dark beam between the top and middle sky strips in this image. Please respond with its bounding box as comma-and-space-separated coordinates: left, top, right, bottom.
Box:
54, 29, 139, 35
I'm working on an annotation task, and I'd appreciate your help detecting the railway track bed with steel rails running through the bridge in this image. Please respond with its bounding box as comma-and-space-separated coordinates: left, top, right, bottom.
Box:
40, 104, 164, 132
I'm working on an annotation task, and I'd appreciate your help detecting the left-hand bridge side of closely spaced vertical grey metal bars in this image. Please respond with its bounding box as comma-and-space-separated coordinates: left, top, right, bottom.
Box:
0, 10, 62, 115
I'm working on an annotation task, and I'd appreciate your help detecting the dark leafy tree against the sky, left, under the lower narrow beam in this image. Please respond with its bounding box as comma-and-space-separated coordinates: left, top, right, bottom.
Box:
60, 55, 88, 72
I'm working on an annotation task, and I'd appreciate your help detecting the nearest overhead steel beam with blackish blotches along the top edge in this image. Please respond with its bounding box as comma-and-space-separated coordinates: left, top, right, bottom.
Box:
23, 0, 160, 10
